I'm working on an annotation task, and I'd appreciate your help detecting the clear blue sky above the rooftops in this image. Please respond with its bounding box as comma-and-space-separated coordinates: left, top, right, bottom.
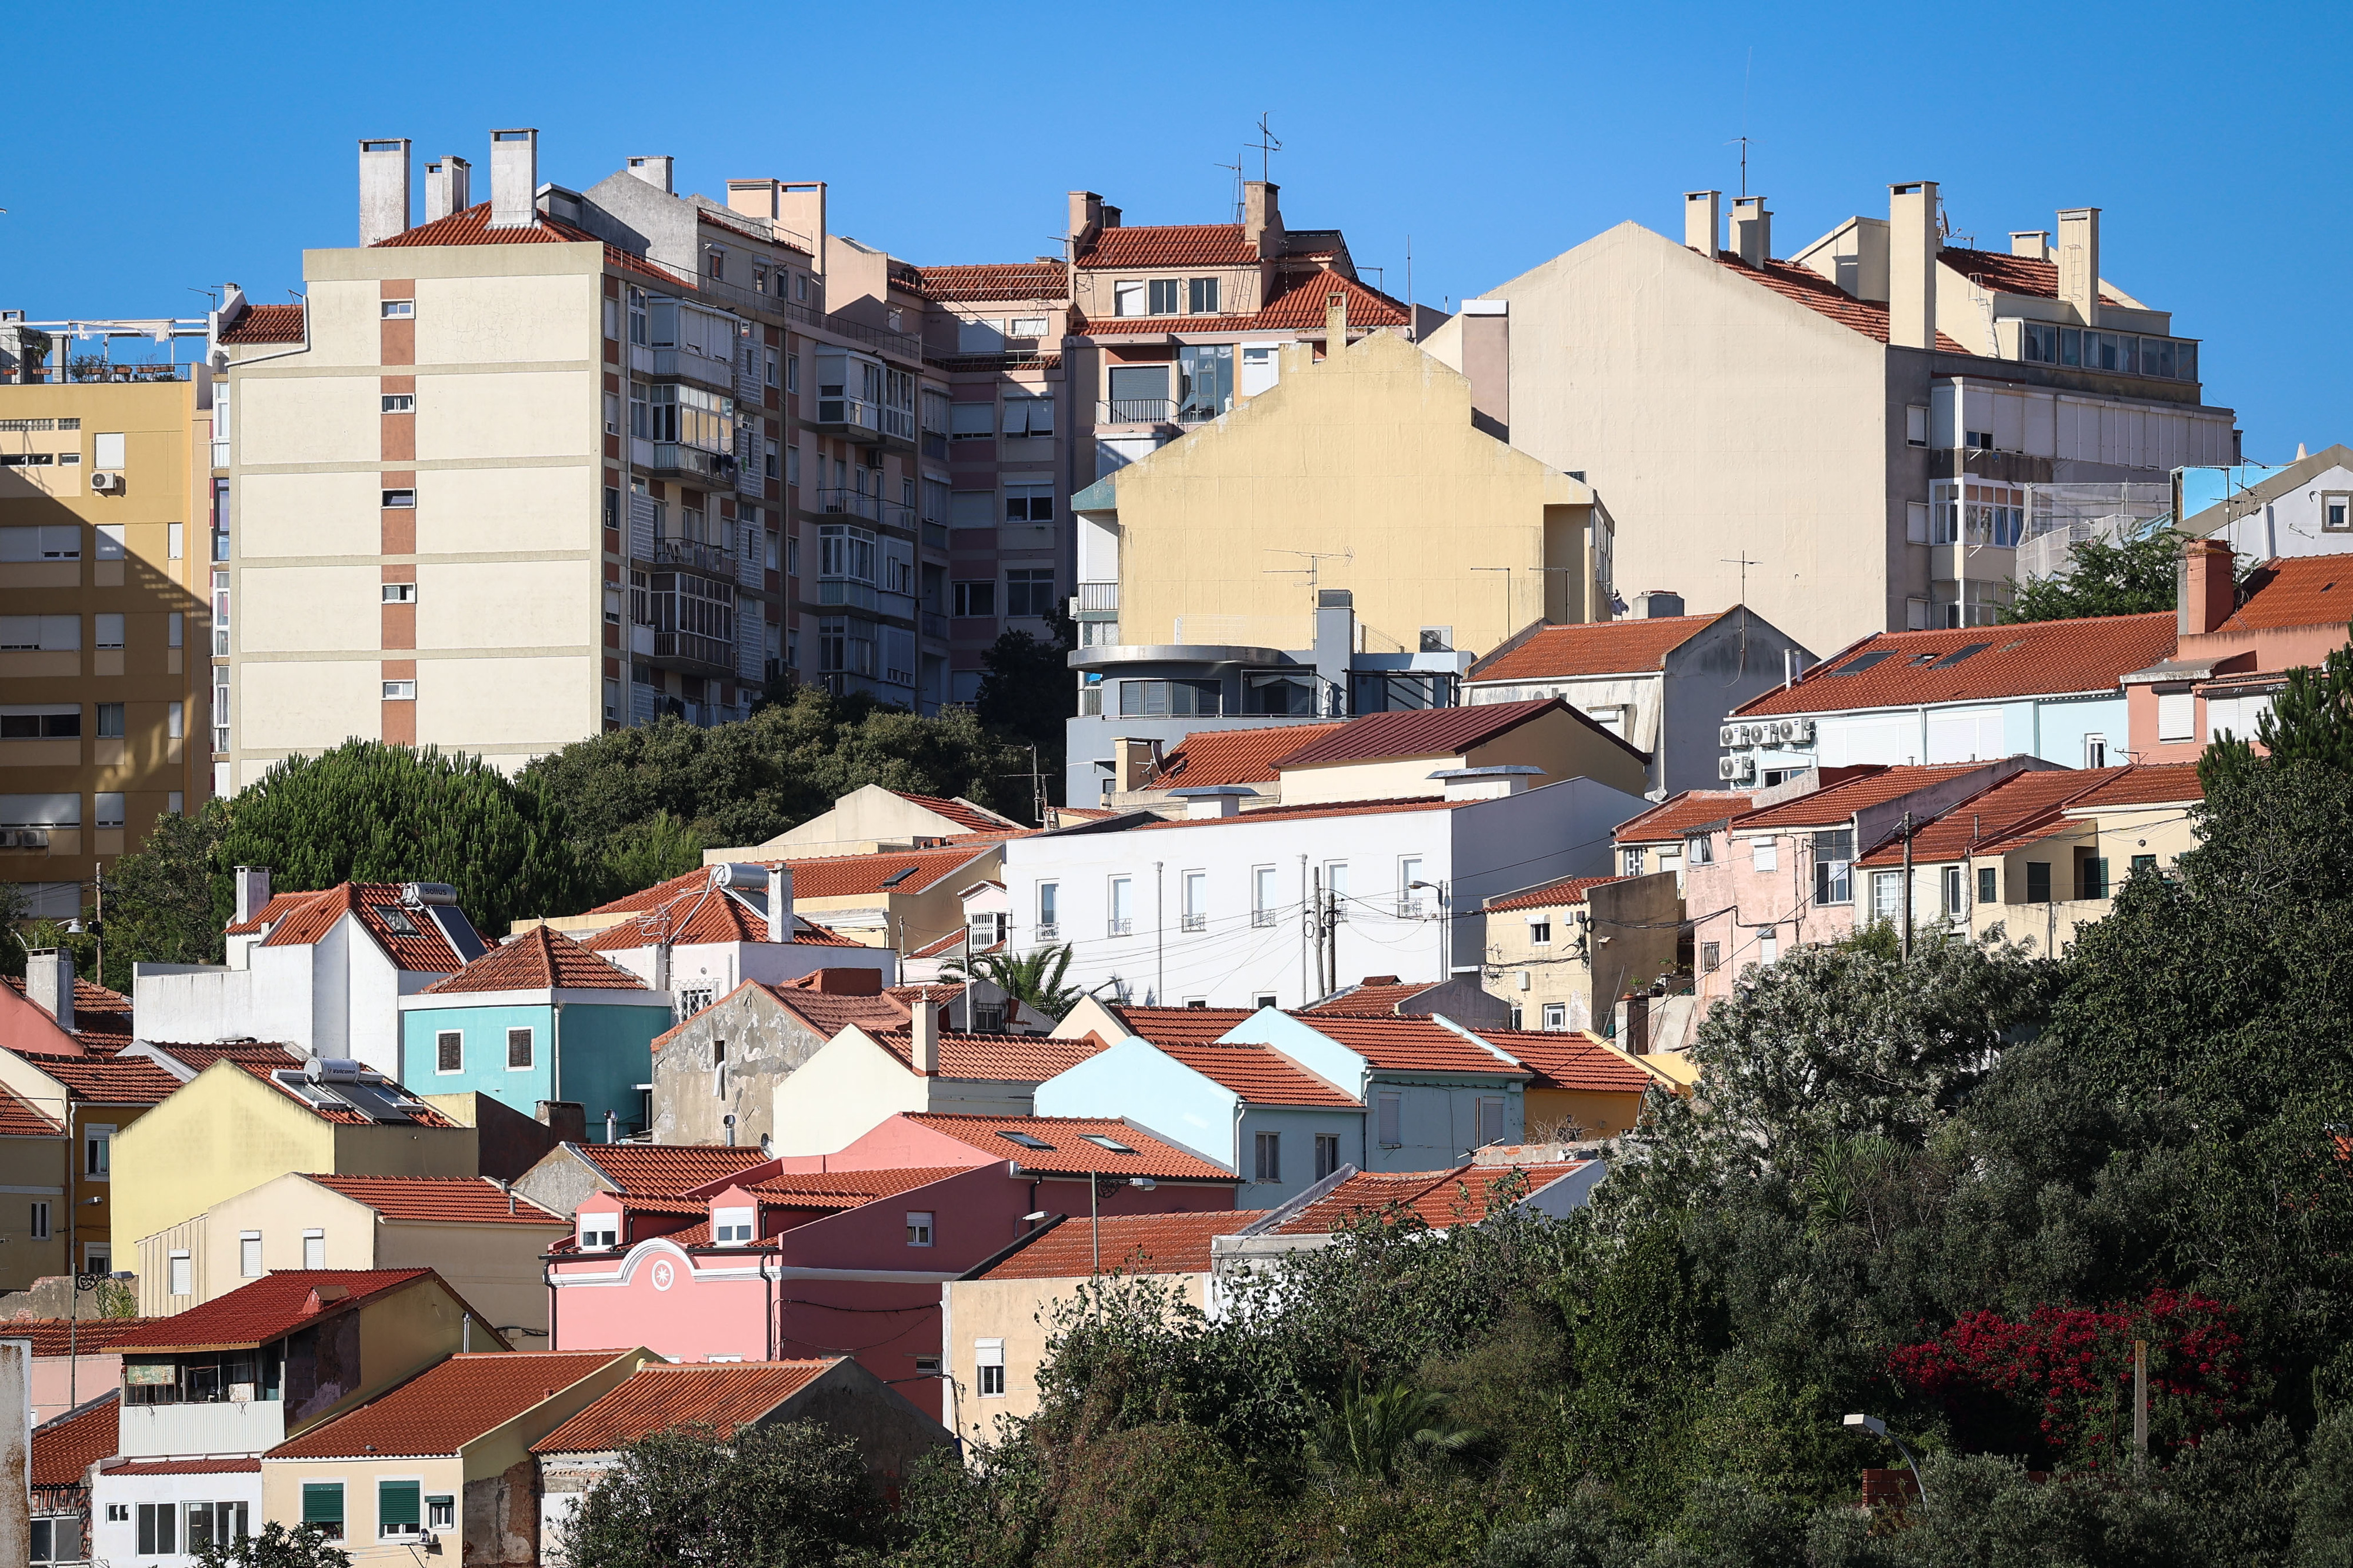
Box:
0, 0, 2353, 462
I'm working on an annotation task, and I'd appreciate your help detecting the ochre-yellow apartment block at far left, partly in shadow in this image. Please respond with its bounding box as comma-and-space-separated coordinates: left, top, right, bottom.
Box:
0, 329, 212, 918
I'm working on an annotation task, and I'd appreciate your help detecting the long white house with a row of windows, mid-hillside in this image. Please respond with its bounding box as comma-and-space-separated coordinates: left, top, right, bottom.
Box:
1005, 765, 1645, 1007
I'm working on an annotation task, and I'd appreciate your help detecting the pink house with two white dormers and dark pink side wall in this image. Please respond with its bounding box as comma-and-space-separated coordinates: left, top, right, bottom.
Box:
548, 1116, 1235, 1420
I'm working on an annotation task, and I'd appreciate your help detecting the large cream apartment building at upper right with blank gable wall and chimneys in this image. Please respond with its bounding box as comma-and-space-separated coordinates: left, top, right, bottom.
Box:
1426, 181, 2238, 648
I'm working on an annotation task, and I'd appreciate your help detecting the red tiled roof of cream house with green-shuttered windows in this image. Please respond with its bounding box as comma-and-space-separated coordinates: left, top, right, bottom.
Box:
266, 1352, 628, 1460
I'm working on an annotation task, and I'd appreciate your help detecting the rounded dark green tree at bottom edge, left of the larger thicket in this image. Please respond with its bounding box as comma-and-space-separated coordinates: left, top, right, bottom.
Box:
565, 1422, 885, 1568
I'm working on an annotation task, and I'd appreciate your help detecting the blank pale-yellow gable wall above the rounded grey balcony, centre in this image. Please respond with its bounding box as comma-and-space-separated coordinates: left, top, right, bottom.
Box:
1118, 332, 1591, 650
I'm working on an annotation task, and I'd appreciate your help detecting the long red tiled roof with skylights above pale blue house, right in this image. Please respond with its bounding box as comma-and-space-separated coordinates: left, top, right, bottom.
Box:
1732, 610, 2177, 716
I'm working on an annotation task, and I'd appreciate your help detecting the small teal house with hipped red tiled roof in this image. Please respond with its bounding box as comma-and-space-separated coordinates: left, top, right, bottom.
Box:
400, 925, 673, 1137
